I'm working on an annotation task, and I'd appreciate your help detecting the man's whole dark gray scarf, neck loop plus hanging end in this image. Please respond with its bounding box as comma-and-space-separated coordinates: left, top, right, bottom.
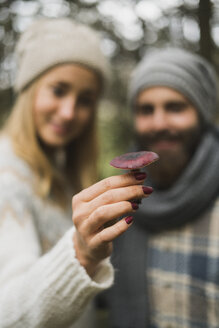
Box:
109, 128, 219, 328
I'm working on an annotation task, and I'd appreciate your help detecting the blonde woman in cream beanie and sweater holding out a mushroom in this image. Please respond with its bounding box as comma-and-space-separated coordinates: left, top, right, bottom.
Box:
0, 19, 150, 328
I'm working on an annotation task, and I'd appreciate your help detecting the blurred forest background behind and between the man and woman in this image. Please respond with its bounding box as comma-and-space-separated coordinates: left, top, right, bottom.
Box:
0, 0, 219, 177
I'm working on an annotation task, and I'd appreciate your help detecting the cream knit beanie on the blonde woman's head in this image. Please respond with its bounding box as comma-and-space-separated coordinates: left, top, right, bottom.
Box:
14, 18, 109, 92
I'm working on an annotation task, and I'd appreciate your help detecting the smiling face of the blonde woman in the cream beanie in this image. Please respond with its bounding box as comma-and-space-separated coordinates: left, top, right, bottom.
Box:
34, 64, 99, 147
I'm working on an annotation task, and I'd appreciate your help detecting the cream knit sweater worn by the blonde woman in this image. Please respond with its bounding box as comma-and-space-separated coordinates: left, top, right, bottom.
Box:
0, 137, 113, 328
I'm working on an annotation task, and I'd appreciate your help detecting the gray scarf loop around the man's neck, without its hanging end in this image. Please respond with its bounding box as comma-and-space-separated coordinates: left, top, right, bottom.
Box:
135, 127, 219, 232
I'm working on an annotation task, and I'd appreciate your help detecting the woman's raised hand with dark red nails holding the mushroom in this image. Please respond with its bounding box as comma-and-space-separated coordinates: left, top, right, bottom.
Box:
72, 172, 152, 276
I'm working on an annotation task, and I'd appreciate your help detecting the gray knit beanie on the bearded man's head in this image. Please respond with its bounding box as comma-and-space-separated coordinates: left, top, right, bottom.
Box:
129, 48, 217, 121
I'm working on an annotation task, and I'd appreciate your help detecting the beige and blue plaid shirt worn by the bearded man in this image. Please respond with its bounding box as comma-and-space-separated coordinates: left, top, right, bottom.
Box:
147, 200, 219, 328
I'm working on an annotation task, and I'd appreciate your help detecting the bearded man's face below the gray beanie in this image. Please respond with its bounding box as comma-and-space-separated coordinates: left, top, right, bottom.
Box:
135, 87, 201, 189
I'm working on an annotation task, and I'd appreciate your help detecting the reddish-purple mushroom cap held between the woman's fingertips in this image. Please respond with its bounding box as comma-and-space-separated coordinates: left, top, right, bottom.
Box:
110, 151, 159, 170
